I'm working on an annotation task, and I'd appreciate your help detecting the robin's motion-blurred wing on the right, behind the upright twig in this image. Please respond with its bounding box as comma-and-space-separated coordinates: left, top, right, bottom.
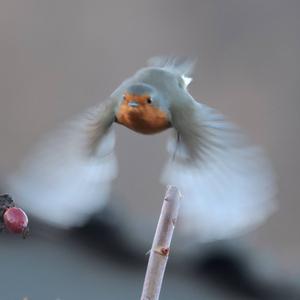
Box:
163, 101, 275, 241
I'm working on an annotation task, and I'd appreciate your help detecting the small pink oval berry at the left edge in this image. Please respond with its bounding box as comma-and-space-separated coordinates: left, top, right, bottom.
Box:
3, 207, 28, 233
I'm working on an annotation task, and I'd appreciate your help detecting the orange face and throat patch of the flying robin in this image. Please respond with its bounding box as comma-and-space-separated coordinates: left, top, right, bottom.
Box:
116, 93, 171, 134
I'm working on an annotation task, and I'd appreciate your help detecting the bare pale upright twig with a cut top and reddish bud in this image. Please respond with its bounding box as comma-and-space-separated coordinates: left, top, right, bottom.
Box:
141, 186, 181, 300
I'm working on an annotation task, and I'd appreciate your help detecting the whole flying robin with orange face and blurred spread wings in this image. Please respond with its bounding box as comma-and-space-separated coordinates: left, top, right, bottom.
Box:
7, 57, 277, 242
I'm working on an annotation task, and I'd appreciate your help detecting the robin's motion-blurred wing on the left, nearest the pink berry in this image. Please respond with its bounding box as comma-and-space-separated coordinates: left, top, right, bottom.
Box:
8, 100, 117, 228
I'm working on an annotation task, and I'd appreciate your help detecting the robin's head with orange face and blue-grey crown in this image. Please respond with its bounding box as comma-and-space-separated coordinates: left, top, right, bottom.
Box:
116, 83, 170, 134
